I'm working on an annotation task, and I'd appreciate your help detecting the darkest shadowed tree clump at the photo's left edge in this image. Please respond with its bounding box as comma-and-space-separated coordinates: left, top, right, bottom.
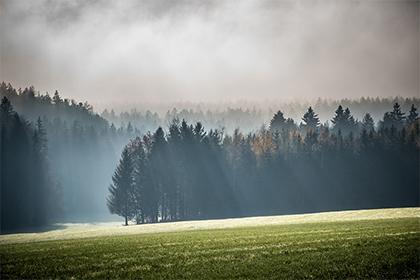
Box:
0, 97, 61, 233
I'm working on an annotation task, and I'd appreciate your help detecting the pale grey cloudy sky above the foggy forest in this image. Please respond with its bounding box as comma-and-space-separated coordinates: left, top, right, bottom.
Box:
0, 0, 420, 107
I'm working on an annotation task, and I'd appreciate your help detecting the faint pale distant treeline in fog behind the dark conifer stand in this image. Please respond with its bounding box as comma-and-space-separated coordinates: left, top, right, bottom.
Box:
101, 97, 420, 134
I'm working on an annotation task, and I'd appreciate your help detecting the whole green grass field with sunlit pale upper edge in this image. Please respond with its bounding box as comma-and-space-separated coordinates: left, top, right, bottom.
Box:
0, 208, 420, 279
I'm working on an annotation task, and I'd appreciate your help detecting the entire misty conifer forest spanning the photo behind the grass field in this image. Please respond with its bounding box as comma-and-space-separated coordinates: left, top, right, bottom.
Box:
0, 82, 420, 232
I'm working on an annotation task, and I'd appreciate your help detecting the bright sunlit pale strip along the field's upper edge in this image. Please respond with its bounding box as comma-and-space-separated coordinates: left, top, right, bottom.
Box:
0, 207, 420, 244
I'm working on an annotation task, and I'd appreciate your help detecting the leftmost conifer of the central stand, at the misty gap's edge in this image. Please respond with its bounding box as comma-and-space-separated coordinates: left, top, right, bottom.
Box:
107, 147, 135, 226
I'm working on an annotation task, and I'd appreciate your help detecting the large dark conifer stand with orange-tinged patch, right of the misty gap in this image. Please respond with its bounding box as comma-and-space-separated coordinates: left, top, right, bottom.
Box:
108, 103, 420, 224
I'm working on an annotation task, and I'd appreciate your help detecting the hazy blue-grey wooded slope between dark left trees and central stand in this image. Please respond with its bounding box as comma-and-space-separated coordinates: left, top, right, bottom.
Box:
0, 82, 135, 221
